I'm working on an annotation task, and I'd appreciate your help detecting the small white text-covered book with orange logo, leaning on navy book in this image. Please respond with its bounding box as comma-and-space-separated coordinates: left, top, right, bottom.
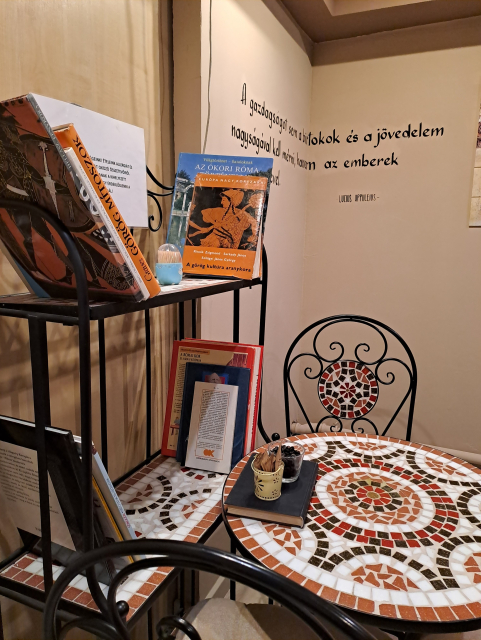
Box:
185, 382, 238, 473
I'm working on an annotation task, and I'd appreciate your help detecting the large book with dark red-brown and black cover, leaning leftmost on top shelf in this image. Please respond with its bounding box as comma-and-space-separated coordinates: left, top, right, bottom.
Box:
0, 94, 158, 301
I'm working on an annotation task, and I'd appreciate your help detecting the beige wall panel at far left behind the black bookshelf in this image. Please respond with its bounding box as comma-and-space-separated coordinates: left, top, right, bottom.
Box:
0, 0, 173, 640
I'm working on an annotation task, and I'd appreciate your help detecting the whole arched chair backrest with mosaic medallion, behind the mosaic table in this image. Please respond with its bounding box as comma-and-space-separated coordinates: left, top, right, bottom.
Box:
283, 315, 417, 440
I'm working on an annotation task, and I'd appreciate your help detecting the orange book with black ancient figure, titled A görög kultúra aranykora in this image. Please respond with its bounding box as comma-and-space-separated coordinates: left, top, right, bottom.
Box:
183, 174, 268, 280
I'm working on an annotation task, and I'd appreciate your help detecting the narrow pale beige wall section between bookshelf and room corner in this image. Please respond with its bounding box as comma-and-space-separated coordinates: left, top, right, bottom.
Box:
197, 0, 311, 440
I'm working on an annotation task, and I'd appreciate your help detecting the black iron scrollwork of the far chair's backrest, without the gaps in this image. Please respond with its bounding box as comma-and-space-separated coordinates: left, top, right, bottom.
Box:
284, 316, 417, 440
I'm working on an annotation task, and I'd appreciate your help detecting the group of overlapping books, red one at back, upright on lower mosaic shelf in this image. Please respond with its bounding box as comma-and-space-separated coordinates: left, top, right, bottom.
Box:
162, 339, 263, 473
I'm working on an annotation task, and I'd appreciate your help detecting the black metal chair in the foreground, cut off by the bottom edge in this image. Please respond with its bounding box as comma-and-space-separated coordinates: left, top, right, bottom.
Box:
43, 539, 375, 640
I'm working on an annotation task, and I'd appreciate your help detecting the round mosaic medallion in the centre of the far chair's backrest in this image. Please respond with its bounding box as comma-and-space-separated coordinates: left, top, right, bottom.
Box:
319, 360, 379, 420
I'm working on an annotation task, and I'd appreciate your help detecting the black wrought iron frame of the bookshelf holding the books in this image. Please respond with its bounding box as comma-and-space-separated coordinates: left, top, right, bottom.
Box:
0, 196, 270, 637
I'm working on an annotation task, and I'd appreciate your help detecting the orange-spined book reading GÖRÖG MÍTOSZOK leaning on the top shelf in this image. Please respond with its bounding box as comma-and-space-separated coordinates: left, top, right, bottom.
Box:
54, 124, 160, 299
